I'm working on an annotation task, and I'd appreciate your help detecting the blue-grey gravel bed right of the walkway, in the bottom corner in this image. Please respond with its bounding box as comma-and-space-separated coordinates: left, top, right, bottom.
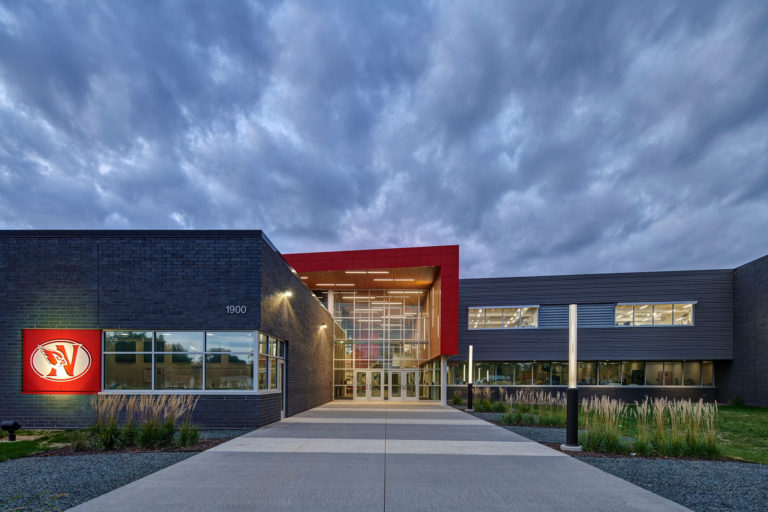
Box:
578, 456, 768, 512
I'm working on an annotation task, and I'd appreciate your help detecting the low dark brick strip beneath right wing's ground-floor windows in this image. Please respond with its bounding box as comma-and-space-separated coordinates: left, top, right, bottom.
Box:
448, 386, 716, 403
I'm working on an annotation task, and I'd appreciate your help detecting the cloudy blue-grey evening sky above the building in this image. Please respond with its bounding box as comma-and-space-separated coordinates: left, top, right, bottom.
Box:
0, 0, 768, 277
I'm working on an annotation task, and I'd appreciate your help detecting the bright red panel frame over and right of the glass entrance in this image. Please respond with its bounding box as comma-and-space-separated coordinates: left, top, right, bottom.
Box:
283, 245, 459, 356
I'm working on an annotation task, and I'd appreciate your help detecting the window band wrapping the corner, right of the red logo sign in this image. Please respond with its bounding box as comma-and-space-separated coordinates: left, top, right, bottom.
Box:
103, 330, 287, 391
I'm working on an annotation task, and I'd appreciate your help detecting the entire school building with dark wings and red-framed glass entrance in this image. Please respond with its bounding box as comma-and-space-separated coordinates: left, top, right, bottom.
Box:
0, 231, 768, 428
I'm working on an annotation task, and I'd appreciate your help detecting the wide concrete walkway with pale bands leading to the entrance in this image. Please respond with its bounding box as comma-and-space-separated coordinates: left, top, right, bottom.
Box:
71, 402, 687, 512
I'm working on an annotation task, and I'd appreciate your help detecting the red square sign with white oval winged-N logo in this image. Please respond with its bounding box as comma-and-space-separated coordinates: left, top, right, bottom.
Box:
21, 329, 101, 394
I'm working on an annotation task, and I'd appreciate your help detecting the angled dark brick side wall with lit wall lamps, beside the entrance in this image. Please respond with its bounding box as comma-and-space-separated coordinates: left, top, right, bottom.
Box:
261, 243, 334, 416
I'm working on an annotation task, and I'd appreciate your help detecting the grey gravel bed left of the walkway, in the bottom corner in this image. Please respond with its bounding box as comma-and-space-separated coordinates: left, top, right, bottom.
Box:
0, 452, 195, 512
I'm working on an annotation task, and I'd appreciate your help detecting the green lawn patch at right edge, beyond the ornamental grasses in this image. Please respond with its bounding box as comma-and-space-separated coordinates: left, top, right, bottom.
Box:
717, 405, 768, 464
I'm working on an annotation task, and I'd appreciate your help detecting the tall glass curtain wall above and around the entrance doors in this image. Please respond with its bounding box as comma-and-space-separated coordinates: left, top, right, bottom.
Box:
332, 290, 439, 400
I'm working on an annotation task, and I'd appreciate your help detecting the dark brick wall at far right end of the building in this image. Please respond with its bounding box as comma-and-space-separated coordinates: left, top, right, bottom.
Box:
722, 256, 768, 407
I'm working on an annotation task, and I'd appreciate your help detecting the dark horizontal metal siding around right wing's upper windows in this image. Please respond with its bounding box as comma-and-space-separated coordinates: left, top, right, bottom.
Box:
458, 270, 733, 361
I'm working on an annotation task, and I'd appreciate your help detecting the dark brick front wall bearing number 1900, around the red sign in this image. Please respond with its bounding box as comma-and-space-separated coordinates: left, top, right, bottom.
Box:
0, 231, 300, 427
